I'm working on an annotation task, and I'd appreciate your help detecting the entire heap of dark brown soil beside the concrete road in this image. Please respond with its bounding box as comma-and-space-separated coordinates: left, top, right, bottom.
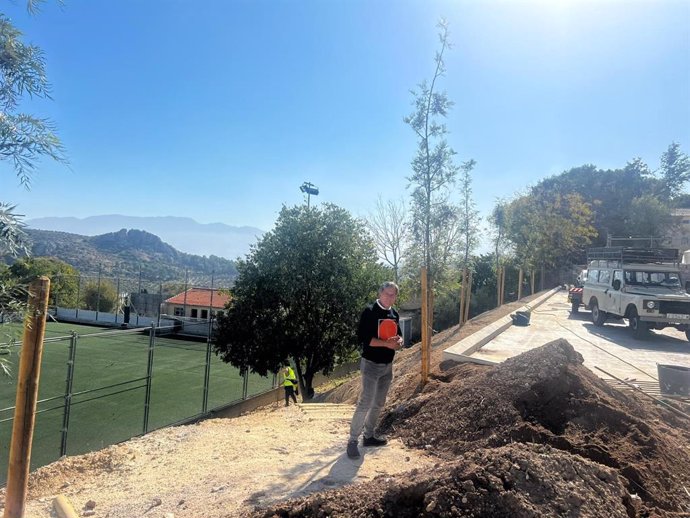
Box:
250, 340, 690, 518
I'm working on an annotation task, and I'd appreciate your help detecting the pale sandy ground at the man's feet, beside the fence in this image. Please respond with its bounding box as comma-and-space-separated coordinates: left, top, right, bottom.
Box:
6, 404, 434, 518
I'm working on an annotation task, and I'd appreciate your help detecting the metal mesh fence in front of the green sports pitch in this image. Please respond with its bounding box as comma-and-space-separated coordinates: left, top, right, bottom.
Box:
0, 322, 276, 483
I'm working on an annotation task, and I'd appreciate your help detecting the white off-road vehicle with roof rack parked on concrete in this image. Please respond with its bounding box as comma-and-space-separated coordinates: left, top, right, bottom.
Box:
582, 247, 690, 340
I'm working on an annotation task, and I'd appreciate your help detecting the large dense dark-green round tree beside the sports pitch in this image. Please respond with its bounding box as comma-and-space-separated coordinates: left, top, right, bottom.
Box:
214, 204, 384, 397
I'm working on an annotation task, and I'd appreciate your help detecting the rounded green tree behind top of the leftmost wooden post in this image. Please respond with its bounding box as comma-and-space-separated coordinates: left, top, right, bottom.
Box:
9, 257, 79, 308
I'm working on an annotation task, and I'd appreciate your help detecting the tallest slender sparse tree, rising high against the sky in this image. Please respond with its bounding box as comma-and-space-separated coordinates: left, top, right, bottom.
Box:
404, 21, 459, 284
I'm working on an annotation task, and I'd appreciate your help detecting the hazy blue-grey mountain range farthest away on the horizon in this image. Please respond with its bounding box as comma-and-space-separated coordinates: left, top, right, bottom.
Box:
25, 214, 264, 259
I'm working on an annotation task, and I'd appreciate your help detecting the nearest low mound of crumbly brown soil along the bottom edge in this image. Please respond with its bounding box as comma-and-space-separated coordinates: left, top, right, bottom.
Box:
253, 444, 636, 518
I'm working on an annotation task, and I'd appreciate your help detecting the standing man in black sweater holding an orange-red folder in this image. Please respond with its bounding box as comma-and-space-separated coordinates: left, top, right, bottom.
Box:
347, 282, 403, 459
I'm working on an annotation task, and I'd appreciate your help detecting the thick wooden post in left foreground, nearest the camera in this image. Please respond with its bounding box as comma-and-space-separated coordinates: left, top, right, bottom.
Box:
5, 276, 50, 518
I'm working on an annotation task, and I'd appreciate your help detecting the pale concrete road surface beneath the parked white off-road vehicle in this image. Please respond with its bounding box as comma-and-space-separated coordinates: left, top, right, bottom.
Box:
471, 291, 690, 382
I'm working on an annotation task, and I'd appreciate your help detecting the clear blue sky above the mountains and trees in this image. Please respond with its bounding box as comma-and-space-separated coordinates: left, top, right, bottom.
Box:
0, 0, 690, 246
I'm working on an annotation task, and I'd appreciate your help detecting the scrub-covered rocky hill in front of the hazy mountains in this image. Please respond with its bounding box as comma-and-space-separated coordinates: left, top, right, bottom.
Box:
26, 228, 237, 284
